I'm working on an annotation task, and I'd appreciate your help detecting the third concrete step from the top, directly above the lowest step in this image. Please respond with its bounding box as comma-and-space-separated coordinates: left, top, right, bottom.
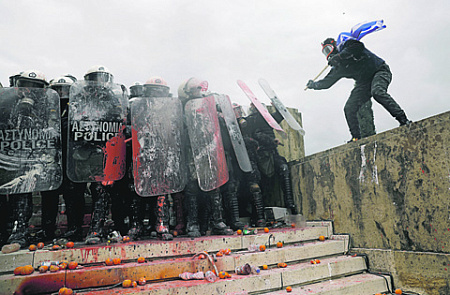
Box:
77, 256, 366, 295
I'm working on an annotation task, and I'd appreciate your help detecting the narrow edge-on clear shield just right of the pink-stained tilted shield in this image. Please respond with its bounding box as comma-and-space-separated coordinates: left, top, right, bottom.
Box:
214, 94, 252, 172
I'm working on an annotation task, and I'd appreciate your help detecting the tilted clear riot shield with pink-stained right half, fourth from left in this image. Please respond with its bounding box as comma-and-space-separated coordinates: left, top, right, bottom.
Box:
184, 96, 229, 191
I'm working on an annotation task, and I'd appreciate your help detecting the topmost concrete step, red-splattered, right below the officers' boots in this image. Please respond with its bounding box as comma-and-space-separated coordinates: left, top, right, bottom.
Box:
0, 222, 332, 273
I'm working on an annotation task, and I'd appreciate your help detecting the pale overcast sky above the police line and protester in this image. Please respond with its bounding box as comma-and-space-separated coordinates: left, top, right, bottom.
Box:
0, 0, 450, 155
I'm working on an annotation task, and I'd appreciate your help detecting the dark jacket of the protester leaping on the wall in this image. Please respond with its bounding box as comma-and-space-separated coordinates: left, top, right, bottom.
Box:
312, 40, 385, 90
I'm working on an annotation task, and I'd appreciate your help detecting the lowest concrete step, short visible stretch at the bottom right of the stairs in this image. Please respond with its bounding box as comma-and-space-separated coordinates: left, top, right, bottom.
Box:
265, 273, 392, 295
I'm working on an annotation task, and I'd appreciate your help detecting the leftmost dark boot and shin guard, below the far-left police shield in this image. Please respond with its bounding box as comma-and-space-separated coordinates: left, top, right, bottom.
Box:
7, 193, 33, 248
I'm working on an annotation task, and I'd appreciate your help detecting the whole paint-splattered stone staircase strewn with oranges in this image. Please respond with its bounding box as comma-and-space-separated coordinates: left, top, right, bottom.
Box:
0, 222, 392, 295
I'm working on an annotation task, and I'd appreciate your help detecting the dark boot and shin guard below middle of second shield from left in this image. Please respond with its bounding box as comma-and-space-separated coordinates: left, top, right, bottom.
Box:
85, 183, 108, 245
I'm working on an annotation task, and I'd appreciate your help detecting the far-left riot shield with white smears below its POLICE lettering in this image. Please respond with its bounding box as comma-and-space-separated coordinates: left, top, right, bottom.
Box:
0, 88, 62, 194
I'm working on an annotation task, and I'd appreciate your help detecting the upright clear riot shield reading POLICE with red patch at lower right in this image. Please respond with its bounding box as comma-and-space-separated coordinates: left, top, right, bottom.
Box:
67, 81, 128, 182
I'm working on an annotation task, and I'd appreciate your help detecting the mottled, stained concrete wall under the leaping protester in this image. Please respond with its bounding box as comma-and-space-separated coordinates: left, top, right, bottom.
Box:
291, 112, 450, 294
